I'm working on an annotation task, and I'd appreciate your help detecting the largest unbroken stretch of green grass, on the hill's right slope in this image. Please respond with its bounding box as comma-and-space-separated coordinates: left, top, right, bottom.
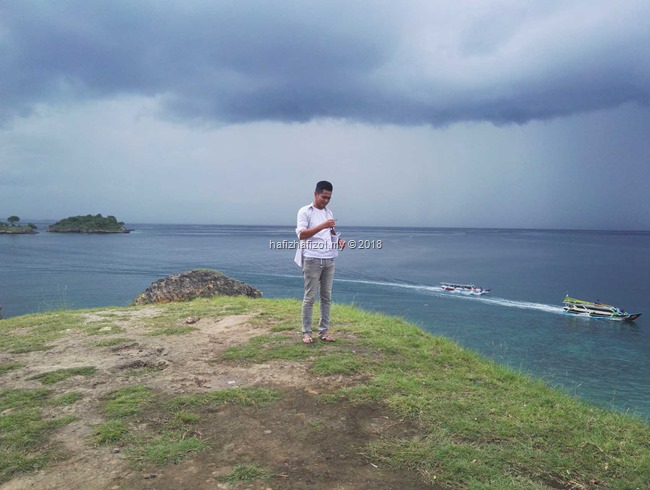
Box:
220, 304, 650, 489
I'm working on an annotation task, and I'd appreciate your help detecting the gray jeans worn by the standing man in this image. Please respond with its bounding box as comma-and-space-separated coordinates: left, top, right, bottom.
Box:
302, 257, 334, 335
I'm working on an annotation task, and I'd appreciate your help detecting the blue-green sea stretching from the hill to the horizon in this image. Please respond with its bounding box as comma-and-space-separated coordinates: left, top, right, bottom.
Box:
0, 224, 650, 420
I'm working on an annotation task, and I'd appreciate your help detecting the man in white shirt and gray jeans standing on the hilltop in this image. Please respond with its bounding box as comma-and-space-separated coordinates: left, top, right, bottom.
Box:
295, 180, 345, 344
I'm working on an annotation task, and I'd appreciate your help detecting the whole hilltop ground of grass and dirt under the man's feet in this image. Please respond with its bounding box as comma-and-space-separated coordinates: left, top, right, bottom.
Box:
0, 297, 650, 489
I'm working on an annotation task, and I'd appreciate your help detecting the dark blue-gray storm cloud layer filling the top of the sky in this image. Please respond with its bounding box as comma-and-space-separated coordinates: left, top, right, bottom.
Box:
0, 0, 650, 125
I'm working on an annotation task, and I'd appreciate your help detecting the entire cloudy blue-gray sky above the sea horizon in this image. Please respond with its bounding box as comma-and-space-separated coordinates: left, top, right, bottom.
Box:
0, 0, 650, 230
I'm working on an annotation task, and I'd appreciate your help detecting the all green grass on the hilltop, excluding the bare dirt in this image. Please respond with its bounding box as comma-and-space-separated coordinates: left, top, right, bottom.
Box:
0, 298, 650, 490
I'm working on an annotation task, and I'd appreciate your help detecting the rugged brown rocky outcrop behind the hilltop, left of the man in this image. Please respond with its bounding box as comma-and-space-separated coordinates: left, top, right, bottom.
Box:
135, 270, 262, 305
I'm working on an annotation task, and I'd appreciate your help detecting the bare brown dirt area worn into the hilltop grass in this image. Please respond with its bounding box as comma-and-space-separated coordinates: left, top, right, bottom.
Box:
0, 307, 431, 490
